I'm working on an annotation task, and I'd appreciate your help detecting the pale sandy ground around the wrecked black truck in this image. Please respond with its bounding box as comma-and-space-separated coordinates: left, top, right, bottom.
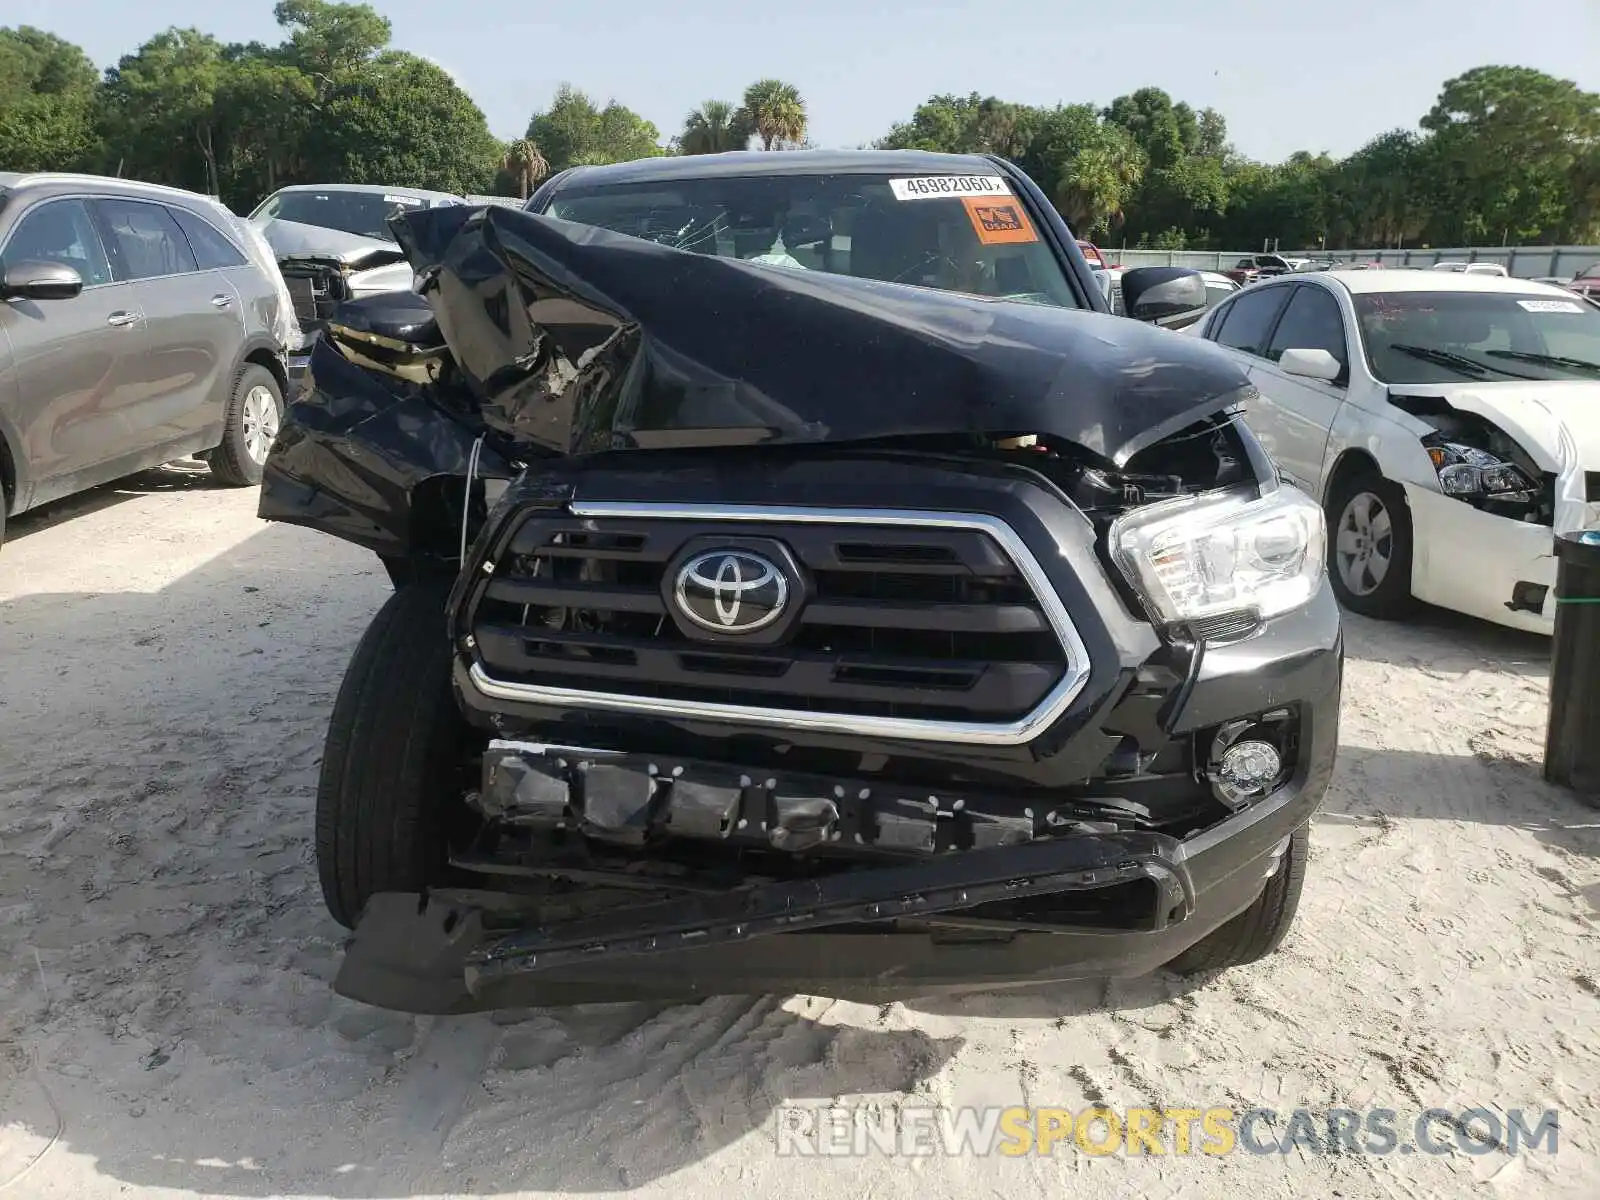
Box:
0, 470, 1600, 1200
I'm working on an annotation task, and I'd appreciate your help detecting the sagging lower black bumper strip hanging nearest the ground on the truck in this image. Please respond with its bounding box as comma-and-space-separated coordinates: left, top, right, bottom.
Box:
334, 795, 1309, 1014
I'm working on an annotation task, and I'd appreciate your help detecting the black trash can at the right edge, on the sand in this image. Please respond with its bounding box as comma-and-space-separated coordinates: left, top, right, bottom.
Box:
1544, 533, 1600, 808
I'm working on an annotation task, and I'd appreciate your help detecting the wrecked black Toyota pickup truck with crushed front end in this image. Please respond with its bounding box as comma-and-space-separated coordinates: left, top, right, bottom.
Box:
261, 152, 1342, 1013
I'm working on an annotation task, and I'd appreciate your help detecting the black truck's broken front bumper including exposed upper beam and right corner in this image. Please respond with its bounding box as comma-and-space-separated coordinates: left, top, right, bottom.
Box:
334, 587, 1342, 1013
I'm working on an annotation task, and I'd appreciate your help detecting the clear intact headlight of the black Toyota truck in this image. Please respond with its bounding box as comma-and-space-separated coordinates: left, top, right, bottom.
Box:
1110, 486, 1328, 624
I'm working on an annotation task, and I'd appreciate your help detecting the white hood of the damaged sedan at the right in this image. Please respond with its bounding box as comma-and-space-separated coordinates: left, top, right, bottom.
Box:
1389, 379, 1600, 472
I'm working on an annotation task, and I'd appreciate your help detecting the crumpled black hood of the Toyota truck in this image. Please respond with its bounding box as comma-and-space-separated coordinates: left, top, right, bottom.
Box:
392, 206, 1248, 466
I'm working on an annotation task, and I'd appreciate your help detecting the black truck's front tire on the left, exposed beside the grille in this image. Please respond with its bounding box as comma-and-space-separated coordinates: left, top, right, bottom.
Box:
317, 582, 475, 928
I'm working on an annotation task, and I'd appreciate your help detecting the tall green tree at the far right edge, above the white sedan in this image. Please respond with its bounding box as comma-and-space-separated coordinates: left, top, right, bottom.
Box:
1422, 66, 1600, 245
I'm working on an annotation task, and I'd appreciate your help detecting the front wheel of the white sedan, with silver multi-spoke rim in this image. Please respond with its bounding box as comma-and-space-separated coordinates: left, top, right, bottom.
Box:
1326, 470, 1416, 621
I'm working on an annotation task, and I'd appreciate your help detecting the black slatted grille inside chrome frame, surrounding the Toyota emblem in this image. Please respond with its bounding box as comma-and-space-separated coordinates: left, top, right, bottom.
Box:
467, 512, 1067, 723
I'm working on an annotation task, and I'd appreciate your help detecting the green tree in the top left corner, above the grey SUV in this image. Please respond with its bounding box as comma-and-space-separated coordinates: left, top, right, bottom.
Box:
0, 26, 99, 171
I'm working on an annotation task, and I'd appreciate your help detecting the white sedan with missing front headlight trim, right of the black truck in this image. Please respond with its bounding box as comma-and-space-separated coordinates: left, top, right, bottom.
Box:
1186, 270, 1600, 634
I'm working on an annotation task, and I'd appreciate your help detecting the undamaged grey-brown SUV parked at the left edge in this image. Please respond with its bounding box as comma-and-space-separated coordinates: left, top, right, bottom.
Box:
0, 173, 299, 538
